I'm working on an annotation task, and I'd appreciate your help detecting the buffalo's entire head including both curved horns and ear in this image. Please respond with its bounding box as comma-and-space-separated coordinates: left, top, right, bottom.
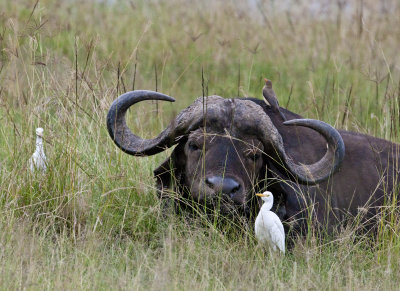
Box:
107, 91, 344, 216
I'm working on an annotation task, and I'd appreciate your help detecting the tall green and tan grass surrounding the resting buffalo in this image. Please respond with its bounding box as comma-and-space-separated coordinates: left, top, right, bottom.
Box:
0, 0, 400, 290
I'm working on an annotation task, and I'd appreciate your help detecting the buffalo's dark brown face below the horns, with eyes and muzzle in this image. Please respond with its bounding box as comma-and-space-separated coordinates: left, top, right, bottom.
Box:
184, 128, 265, 210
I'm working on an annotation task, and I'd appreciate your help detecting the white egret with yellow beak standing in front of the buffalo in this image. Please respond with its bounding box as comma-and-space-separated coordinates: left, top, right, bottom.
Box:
255, 191, 285, 253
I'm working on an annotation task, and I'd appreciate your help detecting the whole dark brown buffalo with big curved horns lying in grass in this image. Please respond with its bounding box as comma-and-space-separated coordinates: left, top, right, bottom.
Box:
107, 86, 400, 235
